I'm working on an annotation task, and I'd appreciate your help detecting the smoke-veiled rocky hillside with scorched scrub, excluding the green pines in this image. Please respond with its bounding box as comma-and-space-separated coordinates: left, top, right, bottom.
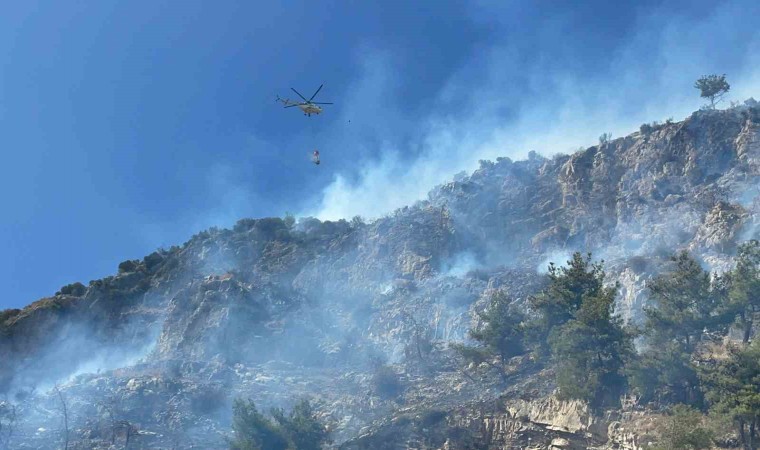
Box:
0, 101, 760, 449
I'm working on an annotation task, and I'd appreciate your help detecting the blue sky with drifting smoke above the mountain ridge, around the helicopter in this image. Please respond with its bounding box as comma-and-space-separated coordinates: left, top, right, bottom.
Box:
0, 0, 760, 308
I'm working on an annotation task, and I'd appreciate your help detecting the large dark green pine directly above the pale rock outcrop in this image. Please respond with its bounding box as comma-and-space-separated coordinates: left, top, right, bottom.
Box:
528, 252, 634, 406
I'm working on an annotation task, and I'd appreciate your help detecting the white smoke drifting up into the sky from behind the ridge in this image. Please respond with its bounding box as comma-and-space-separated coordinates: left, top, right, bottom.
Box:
304, 5, 760, 219
